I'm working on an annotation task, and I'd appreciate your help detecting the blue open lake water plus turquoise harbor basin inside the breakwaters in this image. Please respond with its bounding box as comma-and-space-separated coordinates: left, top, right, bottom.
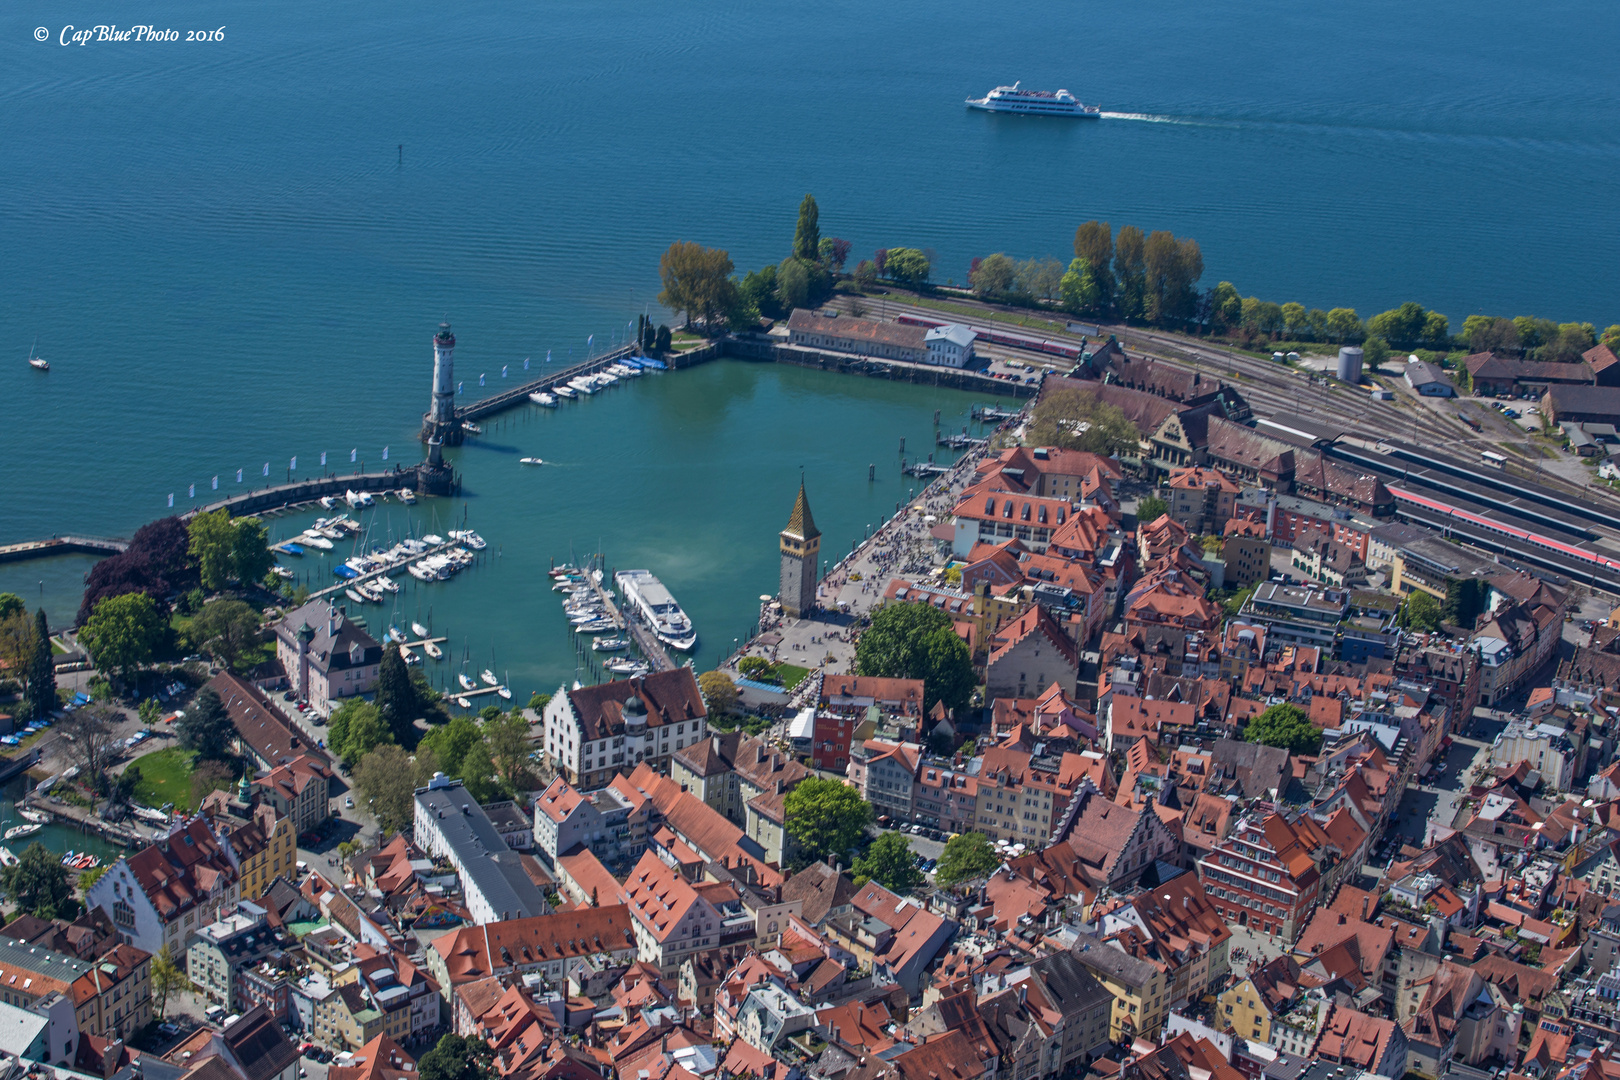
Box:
0, 0, 1620, 682
